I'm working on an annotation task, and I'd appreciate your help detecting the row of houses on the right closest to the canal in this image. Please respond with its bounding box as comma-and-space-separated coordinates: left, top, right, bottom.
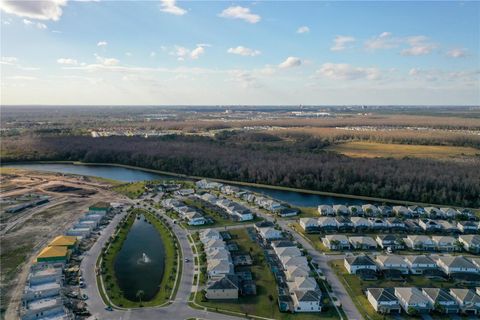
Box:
318, 204, 475, 219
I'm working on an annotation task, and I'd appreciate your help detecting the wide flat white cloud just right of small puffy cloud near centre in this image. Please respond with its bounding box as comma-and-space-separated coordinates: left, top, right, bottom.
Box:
317, 63, 381, 80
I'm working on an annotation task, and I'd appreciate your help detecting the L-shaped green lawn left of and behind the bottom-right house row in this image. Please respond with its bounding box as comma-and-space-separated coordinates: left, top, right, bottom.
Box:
329, 259, 464, 320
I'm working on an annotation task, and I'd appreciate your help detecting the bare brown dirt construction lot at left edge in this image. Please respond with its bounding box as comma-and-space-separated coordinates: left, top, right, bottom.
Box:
0, 169, 128, 319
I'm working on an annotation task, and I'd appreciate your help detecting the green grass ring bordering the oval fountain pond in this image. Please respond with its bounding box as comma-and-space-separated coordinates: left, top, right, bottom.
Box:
97, 209, 181, 308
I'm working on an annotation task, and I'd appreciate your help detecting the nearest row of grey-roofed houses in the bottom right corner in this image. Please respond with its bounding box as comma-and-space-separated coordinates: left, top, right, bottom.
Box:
366, 287, 480, 315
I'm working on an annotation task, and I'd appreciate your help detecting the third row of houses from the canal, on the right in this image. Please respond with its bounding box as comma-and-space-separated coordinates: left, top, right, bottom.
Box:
322, 234, 480, 253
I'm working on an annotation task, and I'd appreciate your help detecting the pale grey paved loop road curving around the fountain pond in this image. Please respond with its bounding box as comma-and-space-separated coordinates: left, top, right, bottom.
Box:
81, 208, 242, 320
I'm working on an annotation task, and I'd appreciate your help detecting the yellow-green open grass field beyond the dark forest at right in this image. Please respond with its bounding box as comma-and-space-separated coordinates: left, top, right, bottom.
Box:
326, 141, 480, 160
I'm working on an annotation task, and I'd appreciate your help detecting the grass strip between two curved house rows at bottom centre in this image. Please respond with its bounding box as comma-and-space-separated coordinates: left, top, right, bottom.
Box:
195, 229, 338, 320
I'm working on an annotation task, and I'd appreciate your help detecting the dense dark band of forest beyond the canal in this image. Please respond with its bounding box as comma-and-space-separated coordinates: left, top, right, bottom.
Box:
2, 135, 480, 207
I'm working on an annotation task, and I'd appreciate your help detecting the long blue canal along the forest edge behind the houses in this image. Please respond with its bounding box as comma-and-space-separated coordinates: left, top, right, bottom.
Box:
5, 163, 372, 207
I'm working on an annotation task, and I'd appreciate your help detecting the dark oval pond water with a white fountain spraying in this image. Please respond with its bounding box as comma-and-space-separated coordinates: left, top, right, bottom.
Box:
114, 216, 165, 301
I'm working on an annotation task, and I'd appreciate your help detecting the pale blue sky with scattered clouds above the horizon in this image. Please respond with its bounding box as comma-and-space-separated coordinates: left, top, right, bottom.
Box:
0, 0, 480, 105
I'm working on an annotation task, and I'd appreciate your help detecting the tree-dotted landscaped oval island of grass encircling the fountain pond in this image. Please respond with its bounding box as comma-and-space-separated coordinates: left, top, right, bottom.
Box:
97, 209, 182, 308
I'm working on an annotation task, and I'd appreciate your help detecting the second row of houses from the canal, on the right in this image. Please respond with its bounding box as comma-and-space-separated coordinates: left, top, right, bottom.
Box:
299, 216, 480, 234
